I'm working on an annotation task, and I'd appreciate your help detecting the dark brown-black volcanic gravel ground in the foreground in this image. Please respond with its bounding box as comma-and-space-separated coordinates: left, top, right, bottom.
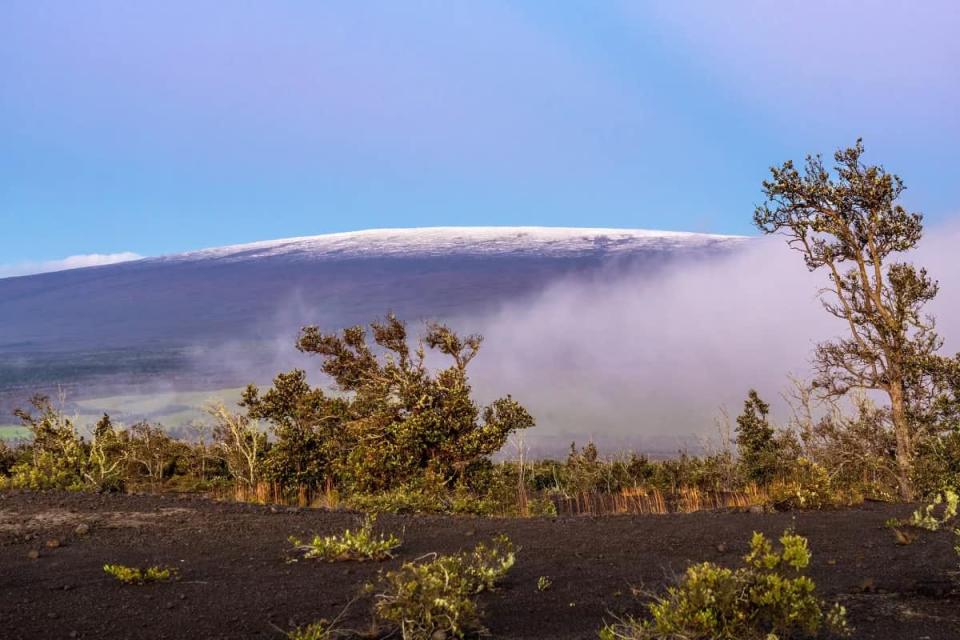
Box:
0, 493, 960, 640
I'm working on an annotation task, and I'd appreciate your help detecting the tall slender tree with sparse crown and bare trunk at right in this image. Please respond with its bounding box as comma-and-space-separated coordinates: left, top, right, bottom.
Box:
754, 140, 957, 499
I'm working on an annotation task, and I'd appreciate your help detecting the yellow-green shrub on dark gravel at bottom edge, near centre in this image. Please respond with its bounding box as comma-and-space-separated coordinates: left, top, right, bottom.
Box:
369, 536, 515, 640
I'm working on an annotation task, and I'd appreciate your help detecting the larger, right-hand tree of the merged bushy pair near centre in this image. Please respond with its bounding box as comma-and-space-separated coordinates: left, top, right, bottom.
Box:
297, 315, 534, 491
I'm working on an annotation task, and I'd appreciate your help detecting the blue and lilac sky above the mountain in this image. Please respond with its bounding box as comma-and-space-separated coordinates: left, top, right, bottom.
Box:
0, 0, 960, 264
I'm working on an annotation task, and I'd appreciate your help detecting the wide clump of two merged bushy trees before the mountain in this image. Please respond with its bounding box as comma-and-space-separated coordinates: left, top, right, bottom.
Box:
243, 315, 534, 494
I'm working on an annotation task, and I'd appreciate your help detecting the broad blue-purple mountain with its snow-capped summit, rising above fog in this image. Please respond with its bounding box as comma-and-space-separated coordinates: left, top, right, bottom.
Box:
0, 227, 744, 393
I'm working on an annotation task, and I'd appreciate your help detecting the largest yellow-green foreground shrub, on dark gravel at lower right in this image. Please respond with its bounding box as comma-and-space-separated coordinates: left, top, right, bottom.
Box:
600, 532, 847, 640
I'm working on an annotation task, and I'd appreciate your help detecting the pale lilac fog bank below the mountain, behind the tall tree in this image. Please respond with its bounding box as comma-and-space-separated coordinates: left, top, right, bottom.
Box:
464, 226, 960, 452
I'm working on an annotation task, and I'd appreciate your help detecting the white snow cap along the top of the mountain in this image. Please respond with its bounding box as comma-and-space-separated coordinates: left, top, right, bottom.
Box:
153, 227, 744, 262
